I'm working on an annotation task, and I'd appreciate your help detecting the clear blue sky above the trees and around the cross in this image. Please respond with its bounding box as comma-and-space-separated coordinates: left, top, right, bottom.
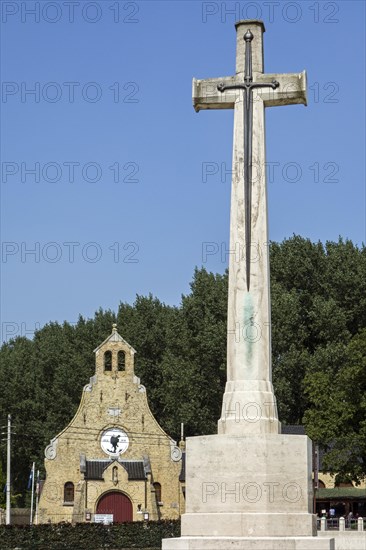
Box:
1, 0, 366, 339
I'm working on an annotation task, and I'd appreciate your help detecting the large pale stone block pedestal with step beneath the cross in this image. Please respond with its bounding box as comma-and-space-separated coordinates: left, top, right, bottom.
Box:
162, 434, 334, 550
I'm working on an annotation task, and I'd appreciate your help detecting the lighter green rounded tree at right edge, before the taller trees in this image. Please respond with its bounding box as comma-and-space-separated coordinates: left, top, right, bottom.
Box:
304, 329, 366, 481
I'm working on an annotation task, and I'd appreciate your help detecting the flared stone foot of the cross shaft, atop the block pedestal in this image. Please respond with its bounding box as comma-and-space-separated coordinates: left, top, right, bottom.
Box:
218, 380, 281, 435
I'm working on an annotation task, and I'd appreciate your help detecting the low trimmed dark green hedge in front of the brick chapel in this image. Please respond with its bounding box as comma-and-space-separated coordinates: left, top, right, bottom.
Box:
0, 520, 180, 550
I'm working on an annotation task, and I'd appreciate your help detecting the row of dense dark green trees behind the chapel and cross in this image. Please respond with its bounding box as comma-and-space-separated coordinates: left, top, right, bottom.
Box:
0, 236, 366, 504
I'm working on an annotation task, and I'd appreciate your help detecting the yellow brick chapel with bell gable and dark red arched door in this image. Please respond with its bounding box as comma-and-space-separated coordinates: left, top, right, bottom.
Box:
37, 325, 184, 523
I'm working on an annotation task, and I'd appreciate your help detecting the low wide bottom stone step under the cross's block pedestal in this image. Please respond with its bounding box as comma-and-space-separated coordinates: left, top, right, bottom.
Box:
162, 537, 335, 550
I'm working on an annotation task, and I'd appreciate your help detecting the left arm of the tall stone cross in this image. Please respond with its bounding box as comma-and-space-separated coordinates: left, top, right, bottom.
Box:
192, 76, 239, 113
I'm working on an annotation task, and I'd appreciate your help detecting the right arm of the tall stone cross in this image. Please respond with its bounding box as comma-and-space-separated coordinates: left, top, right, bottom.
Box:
256, 71, 307, 107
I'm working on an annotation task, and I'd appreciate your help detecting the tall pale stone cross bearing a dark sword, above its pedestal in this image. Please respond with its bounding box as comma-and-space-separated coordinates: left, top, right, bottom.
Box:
193, 20, 306, 435
